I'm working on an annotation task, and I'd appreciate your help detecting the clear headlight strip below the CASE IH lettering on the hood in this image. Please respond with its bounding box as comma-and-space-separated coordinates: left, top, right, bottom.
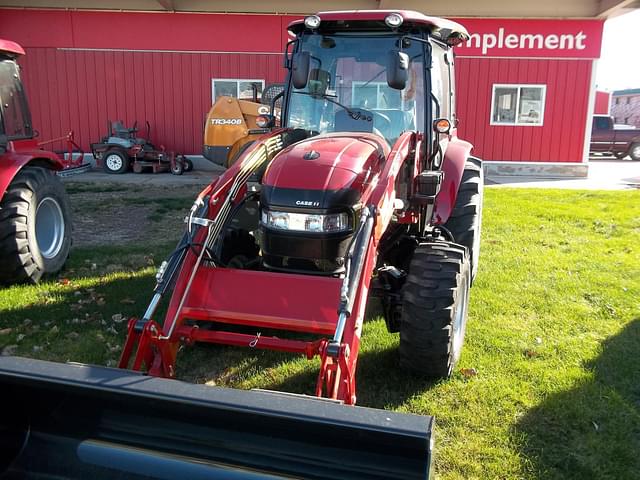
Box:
262, 210, 351, 233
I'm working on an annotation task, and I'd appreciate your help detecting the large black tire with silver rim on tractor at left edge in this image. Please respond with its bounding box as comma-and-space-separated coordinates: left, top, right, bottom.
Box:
0, 166, 72, 284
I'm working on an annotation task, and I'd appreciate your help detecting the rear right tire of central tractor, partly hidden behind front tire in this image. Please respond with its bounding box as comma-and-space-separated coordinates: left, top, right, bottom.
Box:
444, 157, 484, 284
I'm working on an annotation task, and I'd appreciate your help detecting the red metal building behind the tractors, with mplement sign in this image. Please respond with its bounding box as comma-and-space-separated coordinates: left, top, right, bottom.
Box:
0, 2, 620, 175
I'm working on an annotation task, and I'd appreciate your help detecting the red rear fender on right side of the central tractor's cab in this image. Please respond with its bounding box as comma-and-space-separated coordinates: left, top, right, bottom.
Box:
433, 136, 473, 225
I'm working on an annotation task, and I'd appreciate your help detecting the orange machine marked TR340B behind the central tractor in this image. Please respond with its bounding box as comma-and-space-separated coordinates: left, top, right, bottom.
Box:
202, 84, 283, 168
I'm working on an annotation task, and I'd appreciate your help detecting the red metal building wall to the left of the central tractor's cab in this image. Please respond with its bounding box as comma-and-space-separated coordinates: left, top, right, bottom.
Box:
0, 9, 293, 154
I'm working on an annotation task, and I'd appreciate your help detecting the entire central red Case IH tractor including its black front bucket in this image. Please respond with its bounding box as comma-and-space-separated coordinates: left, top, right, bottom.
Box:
0, 11, 482, 480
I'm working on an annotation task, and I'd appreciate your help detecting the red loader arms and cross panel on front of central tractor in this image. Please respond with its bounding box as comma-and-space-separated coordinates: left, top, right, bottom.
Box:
118, 129, 422, 404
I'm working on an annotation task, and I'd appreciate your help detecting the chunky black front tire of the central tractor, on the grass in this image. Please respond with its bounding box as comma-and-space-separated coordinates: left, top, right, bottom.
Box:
399, 242, 471, 379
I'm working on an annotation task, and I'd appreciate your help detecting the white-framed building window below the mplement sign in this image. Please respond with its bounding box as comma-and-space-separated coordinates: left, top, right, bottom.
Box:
490, 85, 547, 126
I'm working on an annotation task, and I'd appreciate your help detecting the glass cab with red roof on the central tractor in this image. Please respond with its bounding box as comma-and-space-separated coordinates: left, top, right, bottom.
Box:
283, 11, 467, 150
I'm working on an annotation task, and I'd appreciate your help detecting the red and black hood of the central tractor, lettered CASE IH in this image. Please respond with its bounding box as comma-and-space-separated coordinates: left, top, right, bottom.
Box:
261, 133, 389, 210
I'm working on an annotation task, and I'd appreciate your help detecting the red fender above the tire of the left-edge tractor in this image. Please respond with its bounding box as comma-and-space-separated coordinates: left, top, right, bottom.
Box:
0, 139, 63, 200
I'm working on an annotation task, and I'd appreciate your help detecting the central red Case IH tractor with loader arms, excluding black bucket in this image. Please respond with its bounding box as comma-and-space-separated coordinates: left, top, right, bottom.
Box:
119, 11, 483, 404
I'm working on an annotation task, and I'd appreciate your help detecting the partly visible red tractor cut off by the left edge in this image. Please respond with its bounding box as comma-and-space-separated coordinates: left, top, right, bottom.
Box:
0, 39, 73, 284
